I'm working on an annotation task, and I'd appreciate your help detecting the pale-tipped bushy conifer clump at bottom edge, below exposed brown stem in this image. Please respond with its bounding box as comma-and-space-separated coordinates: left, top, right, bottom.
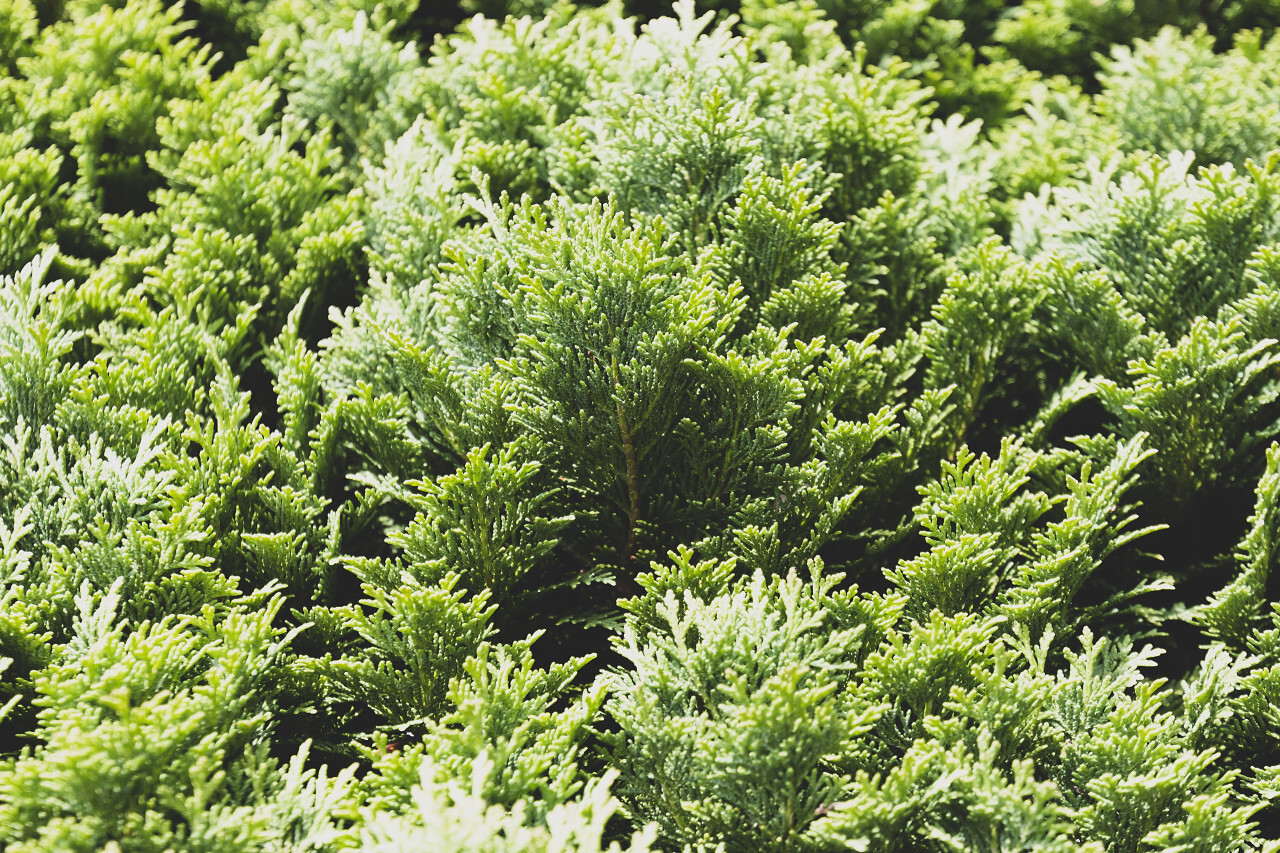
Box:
611, 569, 882, 850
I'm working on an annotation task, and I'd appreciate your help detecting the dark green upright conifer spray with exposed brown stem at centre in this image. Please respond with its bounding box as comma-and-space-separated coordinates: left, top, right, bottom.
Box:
494, 198, 732, 558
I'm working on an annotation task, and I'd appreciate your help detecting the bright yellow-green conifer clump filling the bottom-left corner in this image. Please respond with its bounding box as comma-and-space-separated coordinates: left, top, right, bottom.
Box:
0, 583, 349, 850
